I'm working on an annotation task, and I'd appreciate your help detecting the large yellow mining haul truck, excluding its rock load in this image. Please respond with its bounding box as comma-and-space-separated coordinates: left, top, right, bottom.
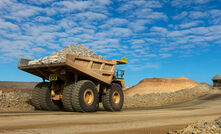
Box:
18, 54, 127, 112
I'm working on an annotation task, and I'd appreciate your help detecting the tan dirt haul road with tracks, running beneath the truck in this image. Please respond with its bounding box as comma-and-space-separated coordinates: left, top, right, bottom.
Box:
0, 91, 221, 134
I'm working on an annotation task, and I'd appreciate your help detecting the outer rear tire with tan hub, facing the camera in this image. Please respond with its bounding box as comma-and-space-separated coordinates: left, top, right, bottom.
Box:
72, 80, 99, 112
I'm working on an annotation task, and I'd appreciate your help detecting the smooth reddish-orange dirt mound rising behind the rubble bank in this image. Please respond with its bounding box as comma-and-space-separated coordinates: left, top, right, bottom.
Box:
125, 77, 199, 96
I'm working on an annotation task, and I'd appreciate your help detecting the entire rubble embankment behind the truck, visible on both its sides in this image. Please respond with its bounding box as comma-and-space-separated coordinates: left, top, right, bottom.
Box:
0, 84, 213, 112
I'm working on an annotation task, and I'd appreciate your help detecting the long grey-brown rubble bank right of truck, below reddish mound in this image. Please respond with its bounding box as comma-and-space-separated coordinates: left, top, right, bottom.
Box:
124, 83, 213, 109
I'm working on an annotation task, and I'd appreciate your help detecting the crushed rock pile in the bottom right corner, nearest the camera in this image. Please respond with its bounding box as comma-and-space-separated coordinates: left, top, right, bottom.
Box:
168, 117, 221, 134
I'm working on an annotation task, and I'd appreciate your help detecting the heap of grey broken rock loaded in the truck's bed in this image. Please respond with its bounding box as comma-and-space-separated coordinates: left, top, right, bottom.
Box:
28, 45, 103, 65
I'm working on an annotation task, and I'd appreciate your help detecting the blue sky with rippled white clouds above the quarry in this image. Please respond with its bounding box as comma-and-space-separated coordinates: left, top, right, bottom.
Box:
0, 0, 221, 85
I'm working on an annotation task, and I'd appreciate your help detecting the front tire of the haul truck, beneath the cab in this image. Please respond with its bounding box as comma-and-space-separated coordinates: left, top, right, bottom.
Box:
102, 83, 124, 112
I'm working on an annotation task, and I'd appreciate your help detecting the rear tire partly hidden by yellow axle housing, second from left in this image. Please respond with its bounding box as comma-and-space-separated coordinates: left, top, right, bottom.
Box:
40, 83, 60, 111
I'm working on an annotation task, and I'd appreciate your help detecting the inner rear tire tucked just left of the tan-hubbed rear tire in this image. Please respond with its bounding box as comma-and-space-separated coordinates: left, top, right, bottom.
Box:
62, 83, 75, 112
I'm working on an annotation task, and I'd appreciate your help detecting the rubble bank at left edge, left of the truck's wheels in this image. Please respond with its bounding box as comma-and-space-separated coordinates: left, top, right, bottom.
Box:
0, 90, 34, 112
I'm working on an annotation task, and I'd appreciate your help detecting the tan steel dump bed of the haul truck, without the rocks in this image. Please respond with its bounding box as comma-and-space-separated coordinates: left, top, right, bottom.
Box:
18, 54, 127, 84
